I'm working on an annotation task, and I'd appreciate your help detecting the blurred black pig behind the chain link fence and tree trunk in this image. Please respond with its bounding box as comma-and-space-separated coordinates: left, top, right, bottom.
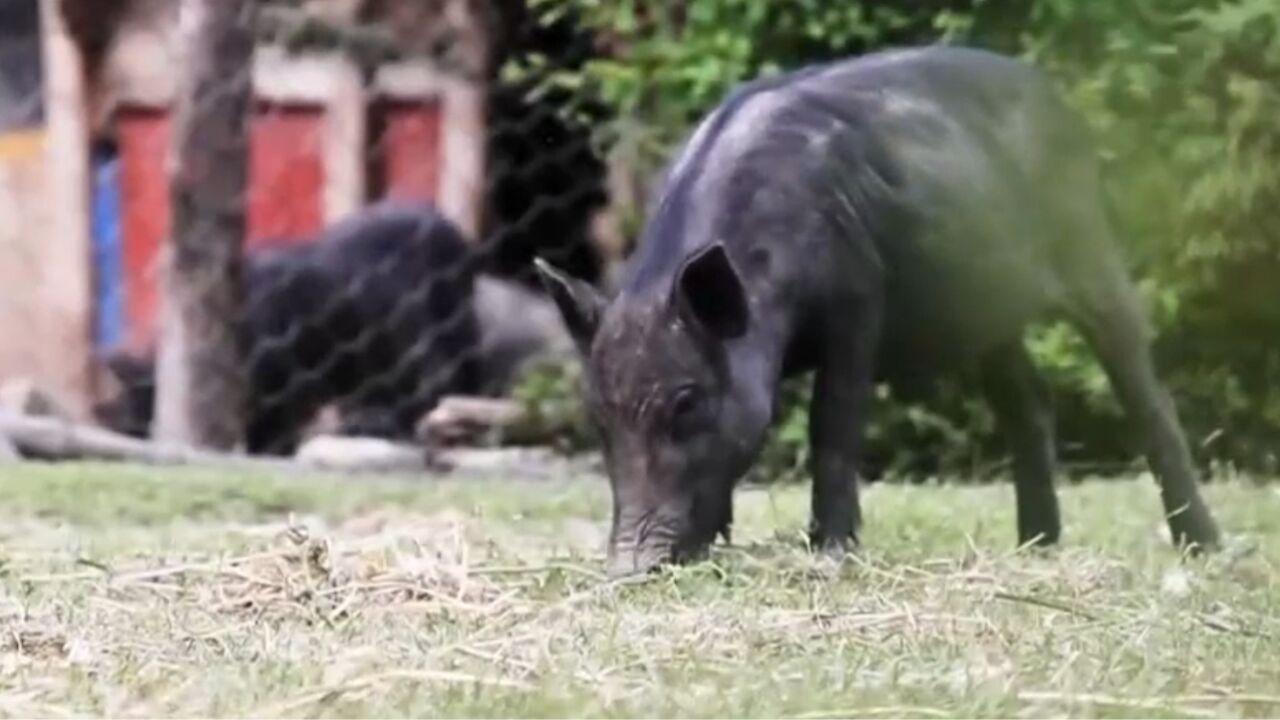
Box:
95, 202, 481, 455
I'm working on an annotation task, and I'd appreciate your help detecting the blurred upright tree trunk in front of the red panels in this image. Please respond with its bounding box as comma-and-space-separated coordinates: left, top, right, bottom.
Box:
155, 0, 259, 450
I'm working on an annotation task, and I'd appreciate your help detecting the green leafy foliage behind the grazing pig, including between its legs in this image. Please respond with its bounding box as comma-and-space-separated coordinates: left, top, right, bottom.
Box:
512, 0, 1280, 475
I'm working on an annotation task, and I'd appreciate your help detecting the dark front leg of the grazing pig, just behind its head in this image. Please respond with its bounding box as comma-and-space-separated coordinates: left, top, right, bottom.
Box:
809, 292, 883, 551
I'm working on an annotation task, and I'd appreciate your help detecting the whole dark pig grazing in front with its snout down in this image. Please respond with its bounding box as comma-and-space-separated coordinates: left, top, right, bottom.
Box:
539, 46, 1219, 573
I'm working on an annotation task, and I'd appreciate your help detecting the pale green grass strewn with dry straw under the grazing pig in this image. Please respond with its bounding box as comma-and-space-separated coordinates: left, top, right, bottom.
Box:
0, 466, 1280, 717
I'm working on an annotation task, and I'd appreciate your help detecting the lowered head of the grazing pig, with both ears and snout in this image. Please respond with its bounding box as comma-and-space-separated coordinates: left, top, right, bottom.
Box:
538, 243, 776, 575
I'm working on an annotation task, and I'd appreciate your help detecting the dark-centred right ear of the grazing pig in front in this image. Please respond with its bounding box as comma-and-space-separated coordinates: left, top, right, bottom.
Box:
675, 242, 750, 340
